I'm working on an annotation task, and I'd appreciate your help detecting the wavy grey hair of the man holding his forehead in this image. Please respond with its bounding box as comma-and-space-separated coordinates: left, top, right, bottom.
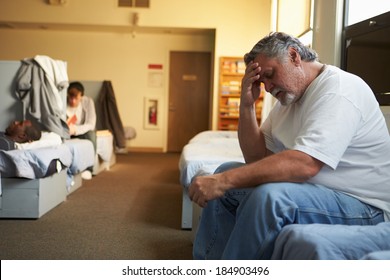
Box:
244, 32, 318, 65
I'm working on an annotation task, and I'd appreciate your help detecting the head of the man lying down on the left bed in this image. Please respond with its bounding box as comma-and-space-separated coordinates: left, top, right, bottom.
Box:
5, 120, 42, 143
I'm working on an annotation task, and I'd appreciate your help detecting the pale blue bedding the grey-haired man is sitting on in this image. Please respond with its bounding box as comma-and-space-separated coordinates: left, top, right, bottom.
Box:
272, 222, 390, 260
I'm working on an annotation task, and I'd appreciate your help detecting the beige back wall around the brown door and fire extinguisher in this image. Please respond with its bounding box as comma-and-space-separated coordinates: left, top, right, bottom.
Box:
0, 0, 271, 150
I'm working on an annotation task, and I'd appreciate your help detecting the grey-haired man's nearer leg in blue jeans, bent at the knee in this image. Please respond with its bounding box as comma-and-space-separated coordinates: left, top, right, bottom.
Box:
222, 183, 384, 259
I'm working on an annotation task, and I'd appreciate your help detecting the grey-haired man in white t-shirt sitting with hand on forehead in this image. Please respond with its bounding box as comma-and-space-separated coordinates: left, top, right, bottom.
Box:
189, 33, 390, 259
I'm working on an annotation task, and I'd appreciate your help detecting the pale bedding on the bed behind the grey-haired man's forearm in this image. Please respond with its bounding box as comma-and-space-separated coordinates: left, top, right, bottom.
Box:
179, 131, 244, 188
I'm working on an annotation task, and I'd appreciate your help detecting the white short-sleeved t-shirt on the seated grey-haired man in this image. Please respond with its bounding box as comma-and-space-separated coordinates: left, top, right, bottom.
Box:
261, 65, 390, 220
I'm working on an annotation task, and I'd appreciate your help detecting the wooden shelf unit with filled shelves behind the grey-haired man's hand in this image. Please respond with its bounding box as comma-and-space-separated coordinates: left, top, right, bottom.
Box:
218, 57, 264, 130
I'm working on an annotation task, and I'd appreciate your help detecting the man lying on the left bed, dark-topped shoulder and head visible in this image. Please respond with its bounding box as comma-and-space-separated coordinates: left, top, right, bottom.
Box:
0, 120, 42, 151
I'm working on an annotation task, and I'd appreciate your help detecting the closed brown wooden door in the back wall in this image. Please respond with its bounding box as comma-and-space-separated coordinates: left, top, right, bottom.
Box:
167, 51, 211, 152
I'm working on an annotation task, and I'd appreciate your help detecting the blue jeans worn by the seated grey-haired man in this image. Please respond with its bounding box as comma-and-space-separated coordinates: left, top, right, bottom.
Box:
193, 162, 384, 259
